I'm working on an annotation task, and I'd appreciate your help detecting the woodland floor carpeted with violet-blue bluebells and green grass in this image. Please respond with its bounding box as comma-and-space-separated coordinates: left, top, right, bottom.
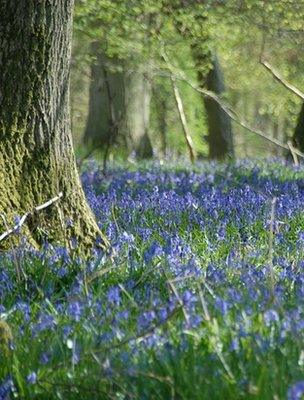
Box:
0, 161, 304, 400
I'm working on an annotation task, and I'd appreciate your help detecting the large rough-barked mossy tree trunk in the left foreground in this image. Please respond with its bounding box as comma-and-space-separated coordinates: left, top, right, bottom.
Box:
0, 0, 105, 248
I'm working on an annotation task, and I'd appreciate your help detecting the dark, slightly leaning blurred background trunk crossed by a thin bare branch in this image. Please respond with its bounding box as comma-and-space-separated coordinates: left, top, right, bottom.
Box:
196, 55, 233, 159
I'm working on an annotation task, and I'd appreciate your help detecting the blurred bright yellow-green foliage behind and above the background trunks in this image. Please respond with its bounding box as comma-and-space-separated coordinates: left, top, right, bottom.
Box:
75, 0, 304, 156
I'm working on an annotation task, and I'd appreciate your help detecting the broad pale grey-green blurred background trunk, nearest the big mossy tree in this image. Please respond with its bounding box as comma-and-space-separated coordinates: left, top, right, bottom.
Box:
84, 47, 153, 158
